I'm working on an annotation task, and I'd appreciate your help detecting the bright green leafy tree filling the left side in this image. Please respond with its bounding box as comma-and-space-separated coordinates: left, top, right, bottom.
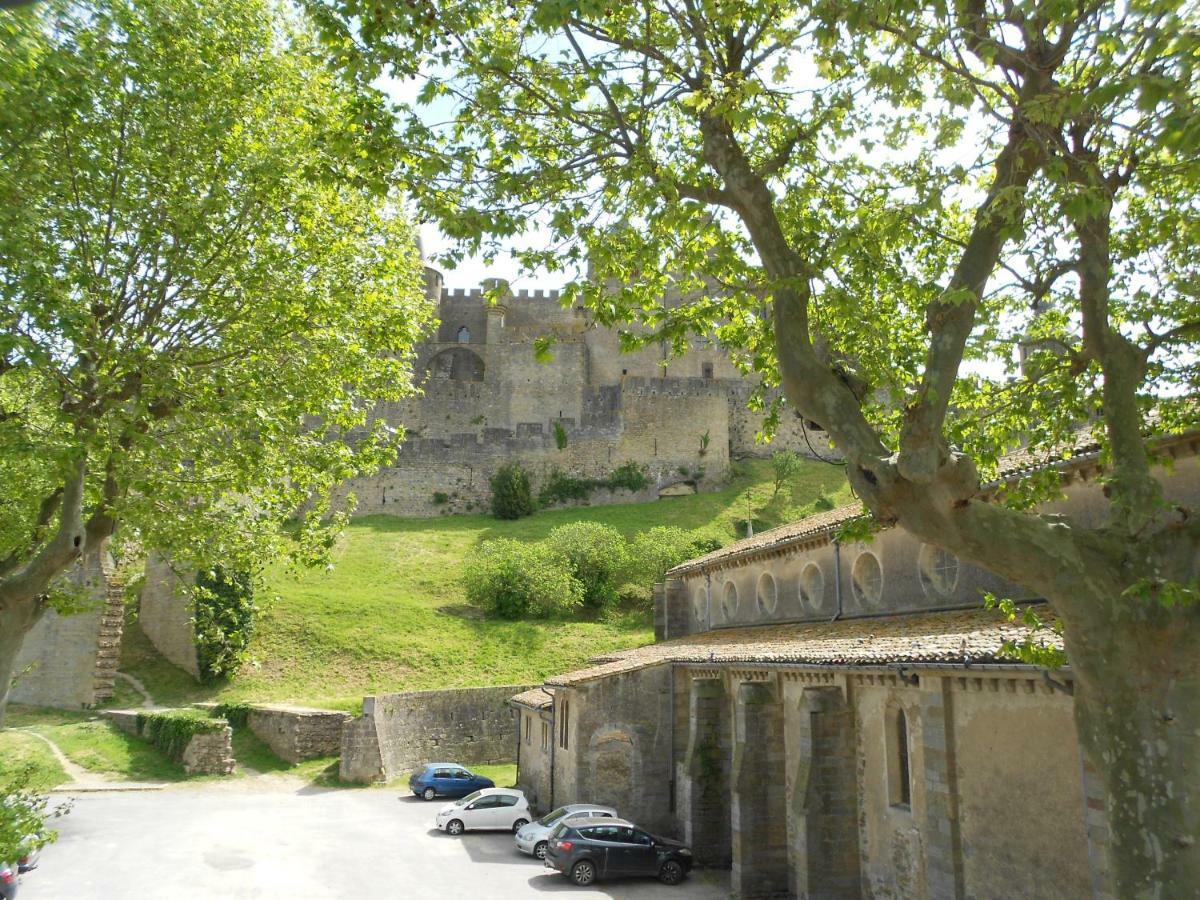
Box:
0, 0, 431, 722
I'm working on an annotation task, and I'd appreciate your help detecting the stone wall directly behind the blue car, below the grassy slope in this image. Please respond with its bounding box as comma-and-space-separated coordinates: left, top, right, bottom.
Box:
340, 684, 529, 782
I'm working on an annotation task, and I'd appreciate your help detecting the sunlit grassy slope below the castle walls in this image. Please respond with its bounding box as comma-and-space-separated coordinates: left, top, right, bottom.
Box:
122, 461, 850, 709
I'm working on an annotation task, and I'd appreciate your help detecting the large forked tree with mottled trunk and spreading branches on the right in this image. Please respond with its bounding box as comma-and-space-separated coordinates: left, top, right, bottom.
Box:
311, 0, 1200, 896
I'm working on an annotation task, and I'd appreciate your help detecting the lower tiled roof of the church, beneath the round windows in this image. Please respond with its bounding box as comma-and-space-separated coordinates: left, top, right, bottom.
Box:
546, 607, 1062, 686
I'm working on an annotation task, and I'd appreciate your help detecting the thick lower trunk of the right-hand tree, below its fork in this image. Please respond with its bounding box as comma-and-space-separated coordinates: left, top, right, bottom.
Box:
1066, 592, 1200, 899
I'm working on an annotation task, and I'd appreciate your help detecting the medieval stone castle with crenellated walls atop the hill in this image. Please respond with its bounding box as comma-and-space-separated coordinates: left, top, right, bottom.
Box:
333, 268, 828, 516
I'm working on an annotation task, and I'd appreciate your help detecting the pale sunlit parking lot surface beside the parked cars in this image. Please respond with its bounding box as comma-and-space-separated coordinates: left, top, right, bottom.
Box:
19, 782, 728, 900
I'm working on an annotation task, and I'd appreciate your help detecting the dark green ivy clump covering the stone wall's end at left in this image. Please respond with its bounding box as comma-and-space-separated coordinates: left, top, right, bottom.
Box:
192, 566, 256, 683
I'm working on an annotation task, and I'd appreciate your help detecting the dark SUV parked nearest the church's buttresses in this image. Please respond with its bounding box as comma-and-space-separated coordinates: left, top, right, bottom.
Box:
546, 818, 691, 884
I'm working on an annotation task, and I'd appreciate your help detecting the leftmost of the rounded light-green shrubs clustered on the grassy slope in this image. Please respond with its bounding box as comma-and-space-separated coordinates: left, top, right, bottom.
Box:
462, 538, 583, 619
